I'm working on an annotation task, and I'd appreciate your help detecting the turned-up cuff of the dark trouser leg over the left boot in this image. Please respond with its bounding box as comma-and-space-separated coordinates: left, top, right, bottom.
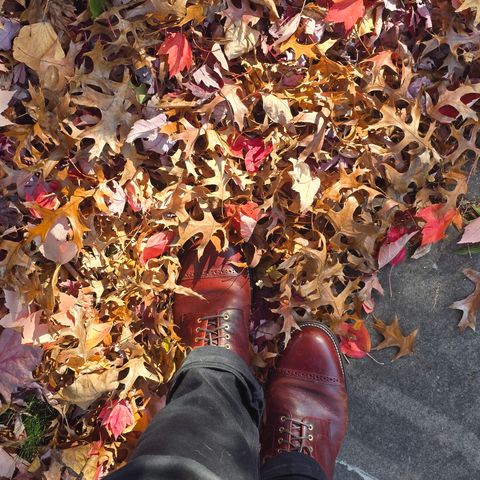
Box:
167, 346, 264, 425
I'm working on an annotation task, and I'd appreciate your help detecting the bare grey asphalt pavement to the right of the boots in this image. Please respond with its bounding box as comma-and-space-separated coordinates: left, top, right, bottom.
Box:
335, 179, 480, 480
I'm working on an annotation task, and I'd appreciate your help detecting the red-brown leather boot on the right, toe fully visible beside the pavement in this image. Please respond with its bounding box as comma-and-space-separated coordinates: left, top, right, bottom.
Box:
261, 322, 348, 479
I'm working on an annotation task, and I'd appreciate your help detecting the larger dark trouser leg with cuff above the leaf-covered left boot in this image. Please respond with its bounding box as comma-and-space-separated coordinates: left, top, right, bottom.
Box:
105, 347, 263, 480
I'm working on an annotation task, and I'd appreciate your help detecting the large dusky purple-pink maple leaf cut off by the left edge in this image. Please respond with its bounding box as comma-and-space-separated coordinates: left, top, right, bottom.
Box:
0, 328, 42, 402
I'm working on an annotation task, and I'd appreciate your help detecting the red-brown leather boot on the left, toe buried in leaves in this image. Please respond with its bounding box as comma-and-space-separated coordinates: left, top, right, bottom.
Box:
173, 244, 255, 364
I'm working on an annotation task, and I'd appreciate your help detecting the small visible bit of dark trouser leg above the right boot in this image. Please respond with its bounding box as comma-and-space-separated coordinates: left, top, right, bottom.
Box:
260, 452, 327, 480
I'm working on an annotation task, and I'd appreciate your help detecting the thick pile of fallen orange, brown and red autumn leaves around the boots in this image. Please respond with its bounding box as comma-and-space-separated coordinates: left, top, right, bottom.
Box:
0, 0, 480, 480
